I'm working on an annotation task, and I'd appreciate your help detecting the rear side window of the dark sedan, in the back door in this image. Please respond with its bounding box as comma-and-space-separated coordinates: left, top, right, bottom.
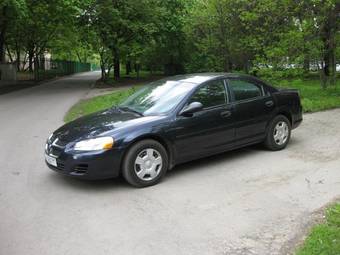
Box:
228, 79, 262, 101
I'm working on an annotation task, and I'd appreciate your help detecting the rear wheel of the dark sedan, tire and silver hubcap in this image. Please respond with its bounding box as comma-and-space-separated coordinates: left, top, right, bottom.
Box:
264, 115, 292, 151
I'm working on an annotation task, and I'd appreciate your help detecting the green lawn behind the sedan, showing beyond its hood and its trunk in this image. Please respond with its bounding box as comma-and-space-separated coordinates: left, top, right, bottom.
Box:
64, 76, 340, 122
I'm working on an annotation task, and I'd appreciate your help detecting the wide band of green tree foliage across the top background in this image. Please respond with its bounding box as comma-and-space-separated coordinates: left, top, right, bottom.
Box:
0, 0, 340, 88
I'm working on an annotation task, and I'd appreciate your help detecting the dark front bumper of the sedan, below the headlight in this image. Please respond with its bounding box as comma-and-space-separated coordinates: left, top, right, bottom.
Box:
45, 148, 123, 180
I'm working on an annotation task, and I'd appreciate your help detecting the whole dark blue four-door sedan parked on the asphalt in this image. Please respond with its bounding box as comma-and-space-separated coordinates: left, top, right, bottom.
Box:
45, 73, 302, 187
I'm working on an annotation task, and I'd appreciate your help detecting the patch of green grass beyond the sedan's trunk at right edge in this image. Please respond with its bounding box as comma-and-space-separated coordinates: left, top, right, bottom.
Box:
273, 79, 340, 112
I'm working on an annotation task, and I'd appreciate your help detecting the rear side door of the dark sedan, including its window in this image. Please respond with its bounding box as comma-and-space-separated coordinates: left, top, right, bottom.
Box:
227, 78, 274, 145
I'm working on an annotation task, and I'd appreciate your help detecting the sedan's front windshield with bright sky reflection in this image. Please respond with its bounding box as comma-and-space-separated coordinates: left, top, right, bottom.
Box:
119, 79, 195, 115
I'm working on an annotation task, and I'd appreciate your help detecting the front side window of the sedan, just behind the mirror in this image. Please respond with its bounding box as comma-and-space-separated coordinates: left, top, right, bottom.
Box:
189, 80, 227, 108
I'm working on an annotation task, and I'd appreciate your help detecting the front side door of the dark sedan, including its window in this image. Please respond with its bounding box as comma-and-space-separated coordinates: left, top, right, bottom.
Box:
173, 79, 235, 162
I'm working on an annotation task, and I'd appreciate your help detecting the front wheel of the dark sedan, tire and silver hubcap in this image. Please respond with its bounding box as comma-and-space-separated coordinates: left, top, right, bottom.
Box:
122, 139, 169, 188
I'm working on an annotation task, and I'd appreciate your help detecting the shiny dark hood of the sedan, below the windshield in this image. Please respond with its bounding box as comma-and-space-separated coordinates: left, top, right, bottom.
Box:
53, 108, 157, 142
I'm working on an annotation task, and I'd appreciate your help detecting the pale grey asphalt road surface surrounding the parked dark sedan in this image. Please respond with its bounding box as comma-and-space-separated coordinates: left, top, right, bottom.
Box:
0, 73, 340, 255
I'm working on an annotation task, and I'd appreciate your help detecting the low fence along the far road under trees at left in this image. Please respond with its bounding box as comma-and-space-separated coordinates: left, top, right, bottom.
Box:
16, 60, 91, 81
